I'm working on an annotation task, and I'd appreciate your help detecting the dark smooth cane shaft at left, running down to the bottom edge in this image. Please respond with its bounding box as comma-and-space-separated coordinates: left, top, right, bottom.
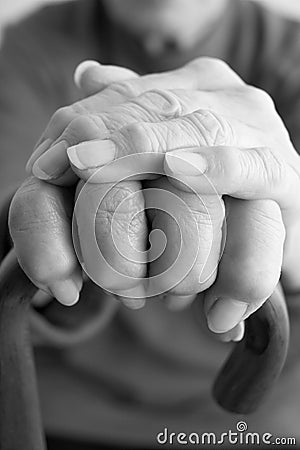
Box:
0, 251, 45, 450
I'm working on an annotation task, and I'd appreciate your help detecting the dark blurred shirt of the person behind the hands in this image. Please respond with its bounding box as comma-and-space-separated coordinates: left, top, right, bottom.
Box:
0, 0, 300, 448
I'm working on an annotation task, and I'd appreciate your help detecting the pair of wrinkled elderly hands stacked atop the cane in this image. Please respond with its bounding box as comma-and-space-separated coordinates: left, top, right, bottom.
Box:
10, 58, 300, 338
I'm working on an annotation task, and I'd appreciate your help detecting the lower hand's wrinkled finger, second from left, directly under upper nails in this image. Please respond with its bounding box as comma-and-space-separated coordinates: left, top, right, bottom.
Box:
74, 182, 148, 299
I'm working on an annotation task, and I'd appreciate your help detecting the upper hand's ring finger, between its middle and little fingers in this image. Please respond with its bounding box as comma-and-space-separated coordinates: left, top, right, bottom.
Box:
32, 90, 211, 184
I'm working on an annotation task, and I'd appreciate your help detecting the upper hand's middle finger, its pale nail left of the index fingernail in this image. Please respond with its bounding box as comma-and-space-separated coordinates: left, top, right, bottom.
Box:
68, 110, 253, 183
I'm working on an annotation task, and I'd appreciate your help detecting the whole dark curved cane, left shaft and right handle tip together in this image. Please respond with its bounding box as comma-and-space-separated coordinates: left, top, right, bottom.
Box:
0, 251, 289, 450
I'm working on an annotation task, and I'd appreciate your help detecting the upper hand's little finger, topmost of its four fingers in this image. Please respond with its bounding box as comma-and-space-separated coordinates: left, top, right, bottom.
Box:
28, 58, 244, 176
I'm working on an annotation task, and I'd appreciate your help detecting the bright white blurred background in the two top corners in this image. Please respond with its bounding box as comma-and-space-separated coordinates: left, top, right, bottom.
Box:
0, 0, 300, 41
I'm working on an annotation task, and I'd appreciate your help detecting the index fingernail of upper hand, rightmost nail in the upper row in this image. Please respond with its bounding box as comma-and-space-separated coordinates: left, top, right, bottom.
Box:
165, 150, 207, 176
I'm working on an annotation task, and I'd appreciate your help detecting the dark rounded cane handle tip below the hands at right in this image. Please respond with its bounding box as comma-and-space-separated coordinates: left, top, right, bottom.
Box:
213, 285, 289, 414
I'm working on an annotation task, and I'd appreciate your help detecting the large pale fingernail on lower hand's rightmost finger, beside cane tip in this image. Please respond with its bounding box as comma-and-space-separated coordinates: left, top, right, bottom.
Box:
207, 298, 248, 333
